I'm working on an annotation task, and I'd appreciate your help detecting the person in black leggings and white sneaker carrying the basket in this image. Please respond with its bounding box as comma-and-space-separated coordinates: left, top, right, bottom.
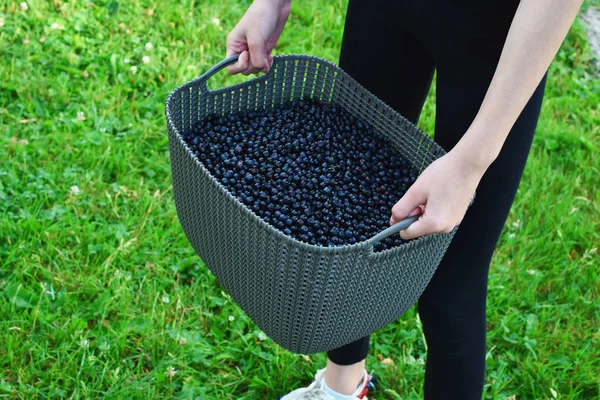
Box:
227, 0, 582, 400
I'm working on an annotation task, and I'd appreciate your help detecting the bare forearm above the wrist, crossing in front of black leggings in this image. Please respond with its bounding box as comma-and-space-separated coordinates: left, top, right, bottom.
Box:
455, 0, 583, 170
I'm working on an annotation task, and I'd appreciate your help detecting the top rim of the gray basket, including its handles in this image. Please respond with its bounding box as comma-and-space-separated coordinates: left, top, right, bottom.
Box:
165, 54, 458, 259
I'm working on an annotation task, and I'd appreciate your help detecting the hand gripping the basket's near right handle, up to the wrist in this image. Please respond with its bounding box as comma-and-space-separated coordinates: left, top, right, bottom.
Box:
390, 150, 487, 239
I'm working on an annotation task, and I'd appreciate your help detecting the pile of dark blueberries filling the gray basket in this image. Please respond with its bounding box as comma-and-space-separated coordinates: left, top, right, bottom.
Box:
184, 99, 416, 250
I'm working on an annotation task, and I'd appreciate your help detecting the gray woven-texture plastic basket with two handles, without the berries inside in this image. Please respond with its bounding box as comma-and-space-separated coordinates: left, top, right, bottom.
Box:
165, 55, 466, 354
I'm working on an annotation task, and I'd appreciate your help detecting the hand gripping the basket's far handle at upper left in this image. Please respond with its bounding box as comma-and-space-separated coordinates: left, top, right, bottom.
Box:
227, 0, 292, 75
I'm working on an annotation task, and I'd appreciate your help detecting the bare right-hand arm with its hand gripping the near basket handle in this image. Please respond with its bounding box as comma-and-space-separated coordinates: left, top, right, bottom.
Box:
390, 0, 583, 239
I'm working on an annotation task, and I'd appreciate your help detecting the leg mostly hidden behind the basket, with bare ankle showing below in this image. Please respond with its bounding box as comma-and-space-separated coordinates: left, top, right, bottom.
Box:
325, 0, 434, 394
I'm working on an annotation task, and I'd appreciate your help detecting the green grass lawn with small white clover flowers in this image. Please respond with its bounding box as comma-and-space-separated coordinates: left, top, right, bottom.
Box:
0, 0, 600, 400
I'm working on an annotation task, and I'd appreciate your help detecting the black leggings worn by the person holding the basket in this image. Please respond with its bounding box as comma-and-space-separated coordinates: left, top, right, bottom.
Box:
327, 0, 546, 400
